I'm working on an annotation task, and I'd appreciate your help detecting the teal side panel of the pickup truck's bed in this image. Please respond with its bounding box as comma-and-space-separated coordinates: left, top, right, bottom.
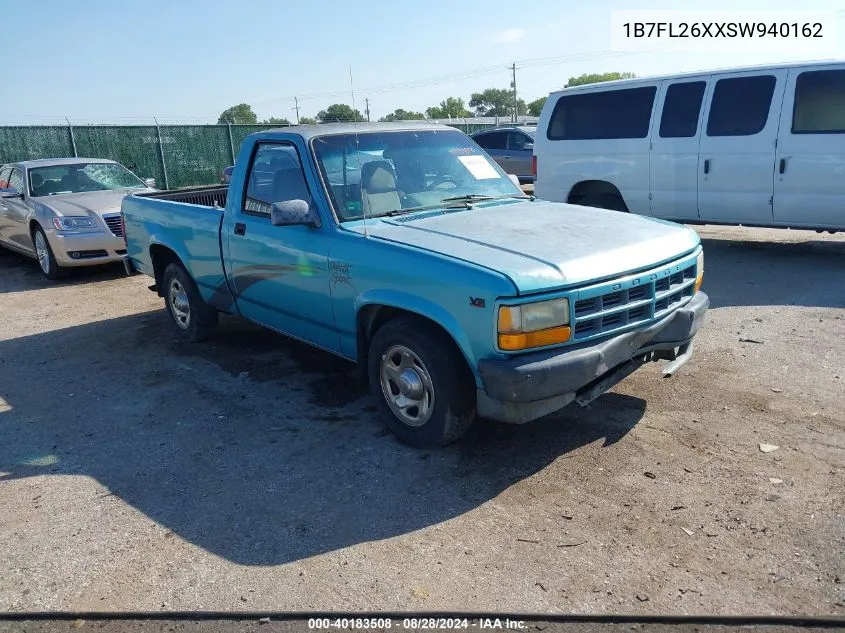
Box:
121, 186, 232, 309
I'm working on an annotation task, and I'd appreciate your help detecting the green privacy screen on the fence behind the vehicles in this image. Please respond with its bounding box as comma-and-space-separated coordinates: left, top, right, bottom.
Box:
0, 124, 489, 189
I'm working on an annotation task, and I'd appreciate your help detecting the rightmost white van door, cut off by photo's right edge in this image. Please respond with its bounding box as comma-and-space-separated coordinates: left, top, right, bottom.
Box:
774, 64, 845, 229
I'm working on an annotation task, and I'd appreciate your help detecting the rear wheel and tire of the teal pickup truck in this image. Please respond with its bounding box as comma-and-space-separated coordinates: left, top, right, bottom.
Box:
161, 262, 218, 343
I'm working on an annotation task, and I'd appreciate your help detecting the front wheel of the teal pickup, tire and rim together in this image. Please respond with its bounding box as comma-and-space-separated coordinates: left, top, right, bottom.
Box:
367, 317, 475, 448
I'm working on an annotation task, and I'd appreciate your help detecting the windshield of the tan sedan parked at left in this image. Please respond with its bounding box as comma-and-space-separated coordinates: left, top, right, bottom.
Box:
29, 163, 146, 197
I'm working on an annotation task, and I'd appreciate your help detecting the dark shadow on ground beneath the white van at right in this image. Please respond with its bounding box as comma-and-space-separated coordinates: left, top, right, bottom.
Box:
701, 238, 845, 308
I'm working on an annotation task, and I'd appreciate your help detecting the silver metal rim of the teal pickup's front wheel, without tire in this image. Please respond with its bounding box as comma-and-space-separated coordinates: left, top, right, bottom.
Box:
379, 345, 434, 427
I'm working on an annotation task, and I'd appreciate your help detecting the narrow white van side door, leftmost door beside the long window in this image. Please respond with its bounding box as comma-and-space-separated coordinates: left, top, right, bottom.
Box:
649, 75, 710, 220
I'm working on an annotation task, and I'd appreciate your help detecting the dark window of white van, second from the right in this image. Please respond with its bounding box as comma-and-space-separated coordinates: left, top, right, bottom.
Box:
707, 75, 776, 136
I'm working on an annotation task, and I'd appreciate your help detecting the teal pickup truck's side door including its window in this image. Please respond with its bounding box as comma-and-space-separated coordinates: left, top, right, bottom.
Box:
222, 141, 340, 352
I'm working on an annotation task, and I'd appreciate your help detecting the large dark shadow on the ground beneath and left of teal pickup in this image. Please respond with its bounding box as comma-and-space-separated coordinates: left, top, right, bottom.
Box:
0, 312, 646, 565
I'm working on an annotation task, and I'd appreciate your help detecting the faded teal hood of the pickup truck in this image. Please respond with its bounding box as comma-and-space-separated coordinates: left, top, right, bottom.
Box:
353, 200, 700, 294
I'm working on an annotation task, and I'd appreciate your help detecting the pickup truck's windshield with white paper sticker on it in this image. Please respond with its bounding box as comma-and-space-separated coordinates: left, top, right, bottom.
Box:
313, 130, 524, 221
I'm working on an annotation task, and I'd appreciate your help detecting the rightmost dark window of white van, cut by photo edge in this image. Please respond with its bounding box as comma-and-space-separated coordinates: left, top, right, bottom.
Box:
792, 70, 845, 134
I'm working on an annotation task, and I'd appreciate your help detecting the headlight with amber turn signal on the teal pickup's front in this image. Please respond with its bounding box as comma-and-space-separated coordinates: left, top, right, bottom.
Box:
498, 299, 572, 352
